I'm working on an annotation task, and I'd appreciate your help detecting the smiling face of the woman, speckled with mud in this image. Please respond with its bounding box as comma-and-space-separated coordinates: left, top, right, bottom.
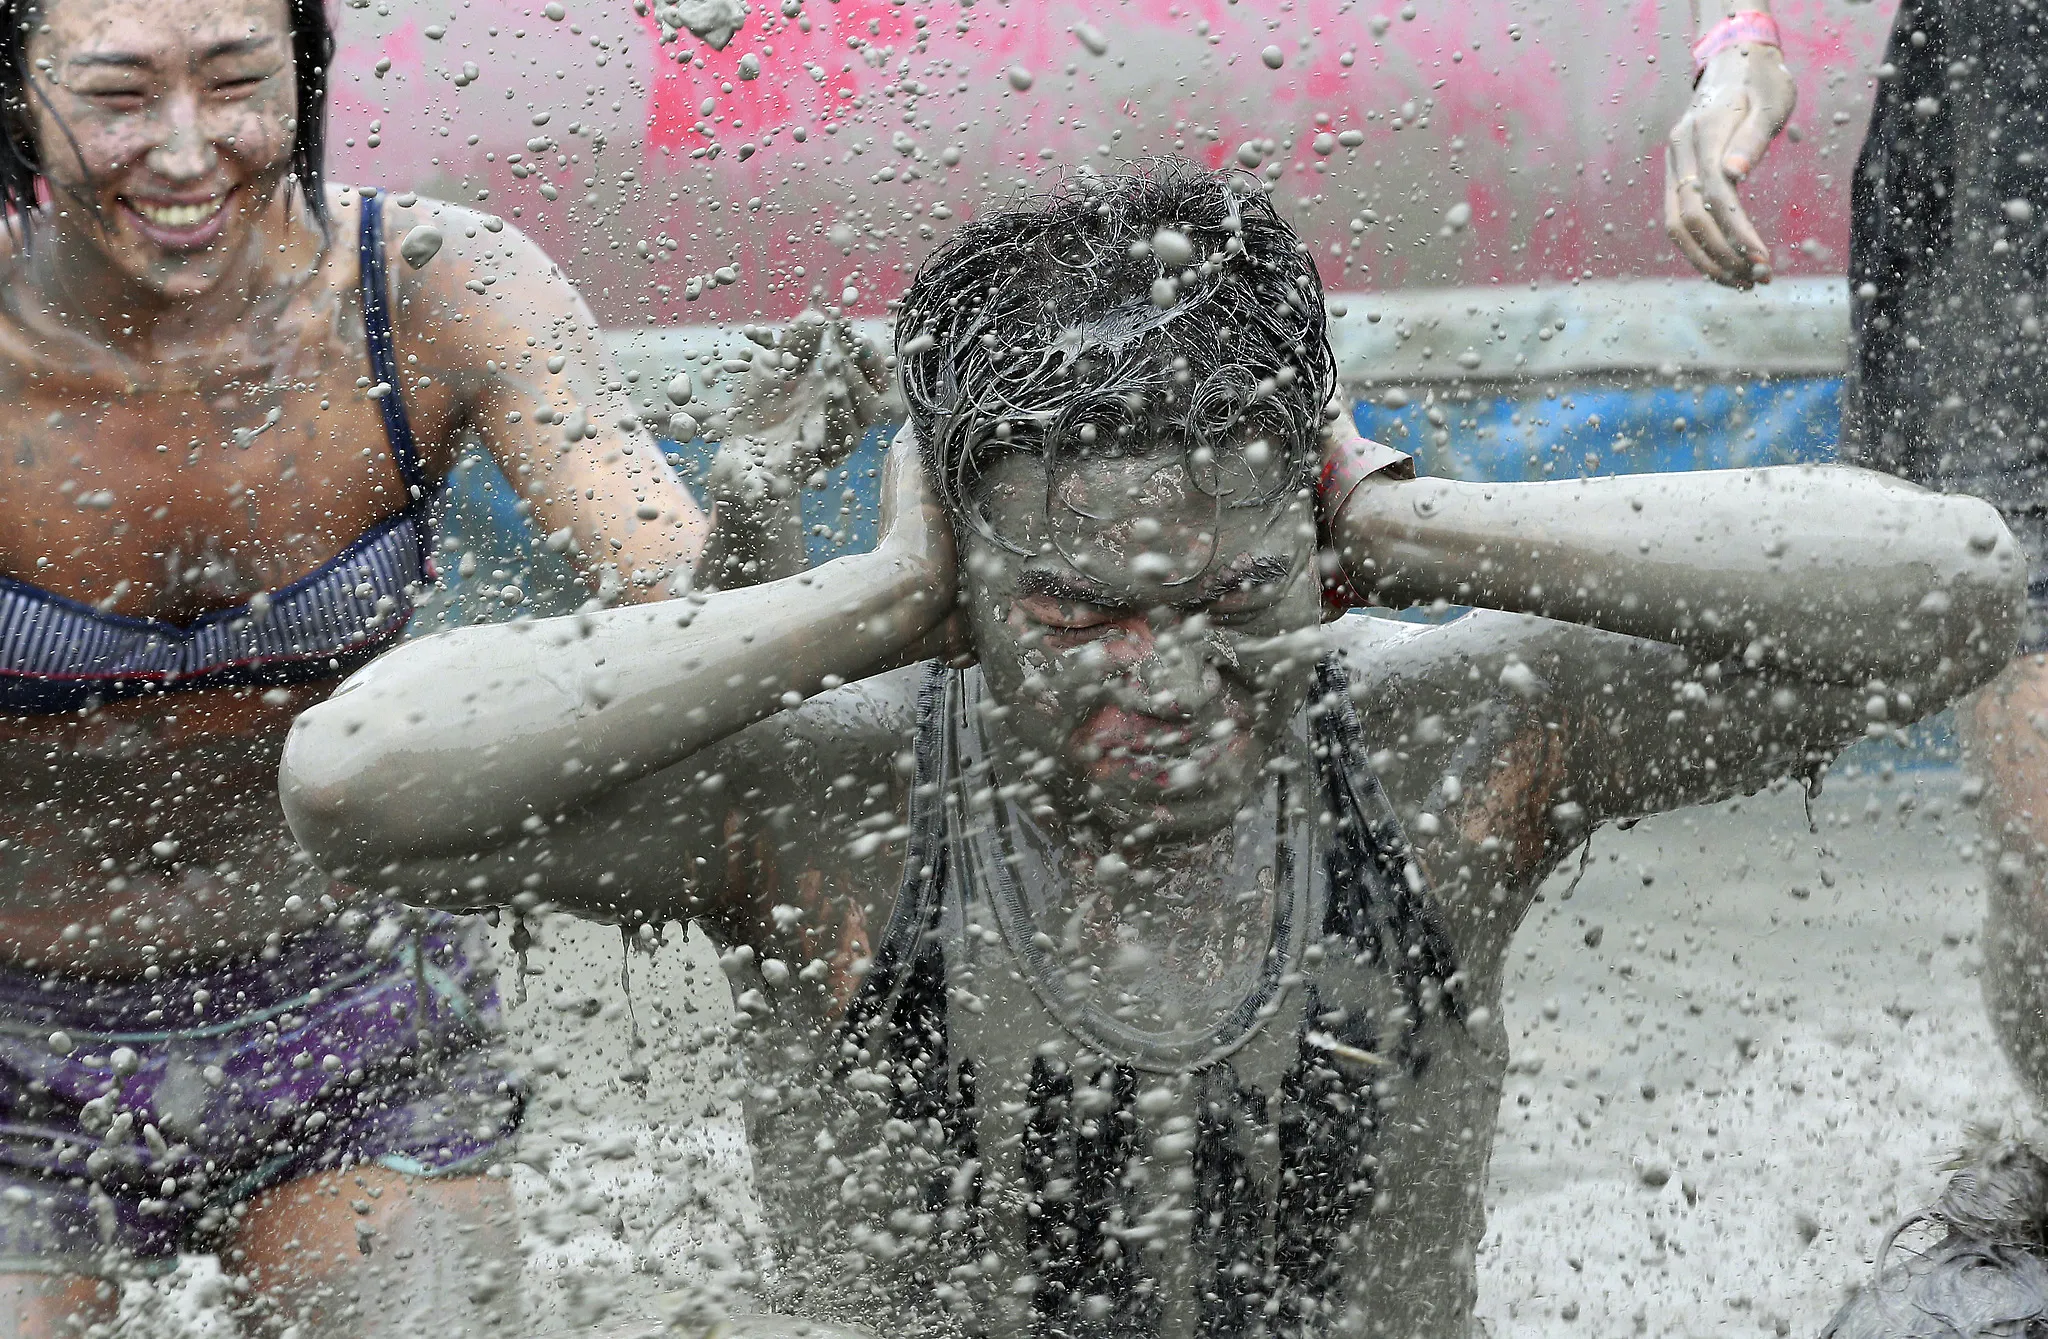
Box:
29, 0, 297, 297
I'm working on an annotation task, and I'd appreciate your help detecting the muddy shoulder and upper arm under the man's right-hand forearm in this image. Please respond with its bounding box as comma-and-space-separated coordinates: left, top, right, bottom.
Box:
1331, 610, 1868, 995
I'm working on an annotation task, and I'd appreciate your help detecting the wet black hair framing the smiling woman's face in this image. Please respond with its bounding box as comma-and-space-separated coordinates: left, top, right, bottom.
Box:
0, 0, 334, 240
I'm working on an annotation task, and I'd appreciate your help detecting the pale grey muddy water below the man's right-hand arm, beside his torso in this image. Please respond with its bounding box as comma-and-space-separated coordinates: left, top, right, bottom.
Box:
1479, 772, 2025, 1337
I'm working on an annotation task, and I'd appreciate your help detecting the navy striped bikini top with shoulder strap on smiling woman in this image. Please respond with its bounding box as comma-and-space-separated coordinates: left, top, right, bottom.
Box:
0, 190, 434, 717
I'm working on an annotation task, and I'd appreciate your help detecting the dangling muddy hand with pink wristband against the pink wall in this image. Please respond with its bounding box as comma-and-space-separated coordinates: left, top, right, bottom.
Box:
1665, 0, 1798, 289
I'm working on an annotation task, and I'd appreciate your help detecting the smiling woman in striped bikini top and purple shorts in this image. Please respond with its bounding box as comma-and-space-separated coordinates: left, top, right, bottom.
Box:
0, 0, 801, 1337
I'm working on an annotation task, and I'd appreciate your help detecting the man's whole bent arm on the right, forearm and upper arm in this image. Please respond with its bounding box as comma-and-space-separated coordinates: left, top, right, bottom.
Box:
1331, 467, 2023, 827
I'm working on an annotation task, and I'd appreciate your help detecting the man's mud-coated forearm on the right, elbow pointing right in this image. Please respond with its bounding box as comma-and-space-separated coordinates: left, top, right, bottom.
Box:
1335, 467, 2025, 682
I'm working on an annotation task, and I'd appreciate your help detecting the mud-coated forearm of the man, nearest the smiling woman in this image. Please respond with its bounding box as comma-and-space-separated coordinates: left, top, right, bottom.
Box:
279, 547, 944, 868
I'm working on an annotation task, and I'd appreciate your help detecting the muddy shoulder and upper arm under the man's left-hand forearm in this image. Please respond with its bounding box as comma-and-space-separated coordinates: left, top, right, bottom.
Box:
352, 665, 922, 1016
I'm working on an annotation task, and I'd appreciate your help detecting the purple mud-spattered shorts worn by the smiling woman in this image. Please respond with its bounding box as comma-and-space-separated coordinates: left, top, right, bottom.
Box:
0, 907, 522, 1273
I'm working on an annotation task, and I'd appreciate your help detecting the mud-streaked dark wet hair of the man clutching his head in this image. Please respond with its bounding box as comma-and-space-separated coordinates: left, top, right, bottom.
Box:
897, 158, 1337, 548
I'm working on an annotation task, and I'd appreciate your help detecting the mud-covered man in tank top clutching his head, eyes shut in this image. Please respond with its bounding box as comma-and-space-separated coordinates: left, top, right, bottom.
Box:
283, 166, 2019, 1335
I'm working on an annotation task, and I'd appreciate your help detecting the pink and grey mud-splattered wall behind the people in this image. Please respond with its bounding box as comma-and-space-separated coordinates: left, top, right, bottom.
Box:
334, 0, 1892, 323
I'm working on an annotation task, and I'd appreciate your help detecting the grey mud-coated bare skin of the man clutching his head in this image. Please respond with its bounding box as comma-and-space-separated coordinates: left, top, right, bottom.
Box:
281, 419, 2019, 1335
